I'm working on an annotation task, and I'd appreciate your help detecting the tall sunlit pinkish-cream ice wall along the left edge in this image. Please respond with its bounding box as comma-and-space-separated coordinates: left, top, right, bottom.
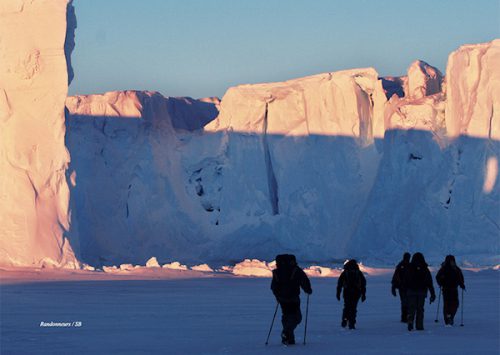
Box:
0, 0, 78, 267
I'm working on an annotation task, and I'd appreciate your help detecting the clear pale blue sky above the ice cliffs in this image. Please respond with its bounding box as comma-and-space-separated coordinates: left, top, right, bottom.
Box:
70, 0, 500, 98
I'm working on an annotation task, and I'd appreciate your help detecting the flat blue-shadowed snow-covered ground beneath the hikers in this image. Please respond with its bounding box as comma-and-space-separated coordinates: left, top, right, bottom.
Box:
0, 269, 500, 354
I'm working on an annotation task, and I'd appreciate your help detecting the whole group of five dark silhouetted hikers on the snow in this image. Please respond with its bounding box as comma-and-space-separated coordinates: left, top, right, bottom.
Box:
271, 253, 465, 345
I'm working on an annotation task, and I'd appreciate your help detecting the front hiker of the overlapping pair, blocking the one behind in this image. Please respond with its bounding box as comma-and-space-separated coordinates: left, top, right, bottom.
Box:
404, 253, 436, 331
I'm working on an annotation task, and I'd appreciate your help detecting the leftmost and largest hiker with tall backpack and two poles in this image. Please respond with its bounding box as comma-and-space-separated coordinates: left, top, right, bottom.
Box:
271, 254, 312, 345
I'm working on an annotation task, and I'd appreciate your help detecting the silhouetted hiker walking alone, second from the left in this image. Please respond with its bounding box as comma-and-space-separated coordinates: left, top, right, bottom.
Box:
337, 259, 366, 329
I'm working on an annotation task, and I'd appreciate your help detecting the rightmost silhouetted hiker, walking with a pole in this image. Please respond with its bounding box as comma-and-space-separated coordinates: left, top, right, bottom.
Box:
436, 255, 465, 325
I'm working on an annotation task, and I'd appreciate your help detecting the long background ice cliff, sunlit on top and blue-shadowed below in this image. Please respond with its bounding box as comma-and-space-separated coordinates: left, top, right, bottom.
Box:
67, 41, 500, 264
